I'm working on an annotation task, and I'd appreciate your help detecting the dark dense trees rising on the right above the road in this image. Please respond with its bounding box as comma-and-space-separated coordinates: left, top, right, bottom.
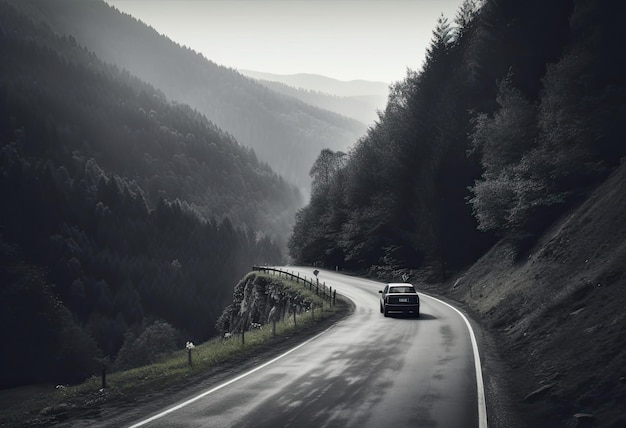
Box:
289, 0, 626, 278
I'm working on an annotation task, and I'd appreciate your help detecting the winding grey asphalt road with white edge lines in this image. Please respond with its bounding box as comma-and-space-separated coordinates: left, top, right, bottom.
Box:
133, 267, 486, 428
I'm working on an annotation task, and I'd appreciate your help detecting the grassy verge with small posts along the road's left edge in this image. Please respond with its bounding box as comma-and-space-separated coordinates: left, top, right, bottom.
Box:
0, 272, 350, 427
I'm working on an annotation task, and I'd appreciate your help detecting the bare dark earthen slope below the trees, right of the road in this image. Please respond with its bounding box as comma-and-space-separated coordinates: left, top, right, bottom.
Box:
448, 165, 626, 427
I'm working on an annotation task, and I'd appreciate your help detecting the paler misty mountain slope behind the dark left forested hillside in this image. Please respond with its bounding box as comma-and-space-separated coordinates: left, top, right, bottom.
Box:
5, 0, 366, 193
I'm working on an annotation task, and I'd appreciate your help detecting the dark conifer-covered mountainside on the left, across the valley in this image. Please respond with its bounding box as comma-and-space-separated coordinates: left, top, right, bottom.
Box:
0, 1, 301, 387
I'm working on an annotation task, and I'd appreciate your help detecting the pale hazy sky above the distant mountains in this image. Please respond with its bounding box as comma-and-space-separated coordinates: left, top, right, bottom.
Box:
105, 0, 462, 83
